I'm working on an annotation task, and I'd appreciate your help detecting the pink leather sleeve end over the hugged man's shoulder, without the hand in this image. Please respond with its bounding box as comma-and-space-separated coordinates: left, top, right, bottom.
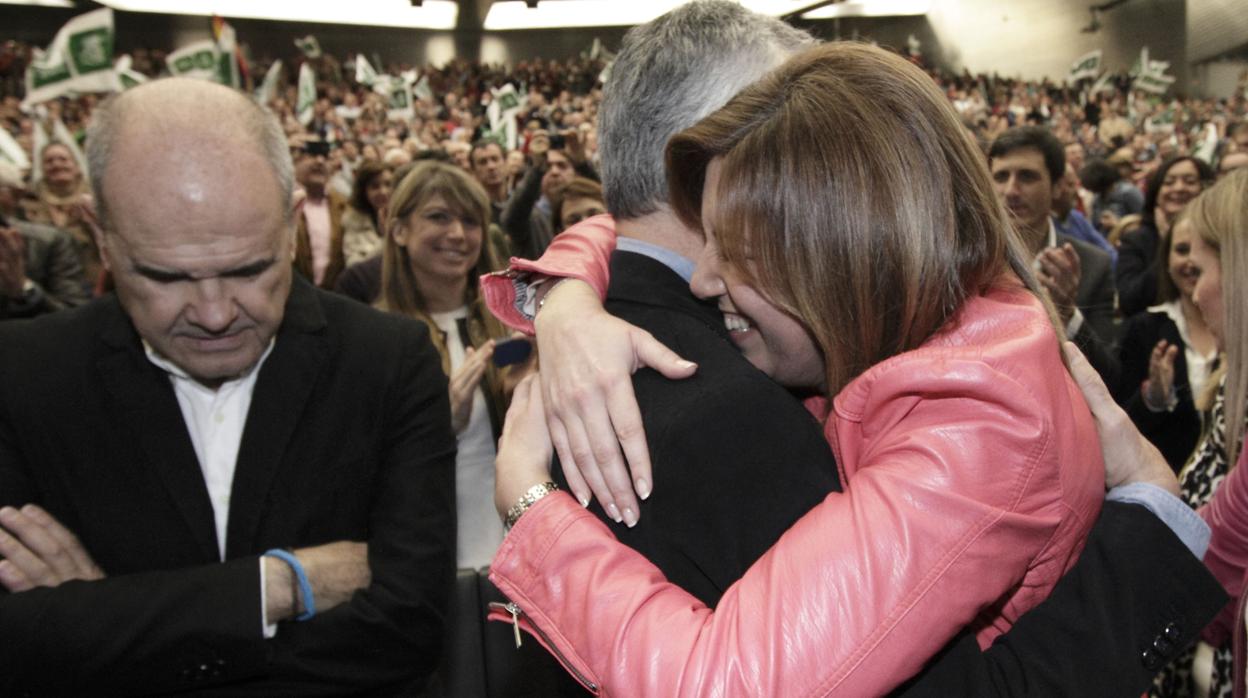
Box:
480, 214, 615, 335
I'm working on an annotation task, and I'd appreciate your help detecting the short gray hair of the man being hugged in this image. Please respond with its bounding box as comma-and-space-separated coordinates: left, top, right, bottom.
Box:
598, 0, 816, 220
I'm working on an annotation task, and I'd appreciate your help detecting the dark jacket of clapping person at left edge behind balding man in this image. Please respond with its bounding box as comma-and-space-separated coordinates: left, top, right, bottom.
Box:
0, 221, 91, 320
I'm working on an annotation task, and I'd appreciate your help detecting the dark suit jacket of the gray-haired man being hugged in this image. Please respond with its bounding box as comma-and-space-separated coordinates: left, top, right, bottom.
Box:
554, 251, 1226, 697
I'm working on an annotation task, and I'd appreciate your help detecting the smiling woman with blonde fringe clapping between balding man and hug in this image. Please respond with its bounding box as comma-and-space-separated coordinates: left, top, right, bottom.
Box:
377, 160, 521, 568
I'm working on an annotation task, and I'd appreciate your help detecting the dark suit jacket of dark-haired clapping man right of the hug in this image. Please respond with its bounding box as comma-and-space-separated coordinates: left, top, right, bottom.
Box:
1057, 233, 1119, 386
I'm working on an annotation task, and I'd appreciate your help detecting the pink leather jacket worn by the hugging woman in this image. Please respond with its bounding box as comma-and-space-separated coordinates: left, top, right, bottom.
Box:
490, 222, 1104, 697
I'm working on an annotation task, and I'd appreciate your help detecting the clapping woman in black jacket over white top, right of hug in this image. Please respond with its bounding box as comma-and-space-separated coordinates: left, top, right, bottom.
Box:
1117, 216, 1217, 473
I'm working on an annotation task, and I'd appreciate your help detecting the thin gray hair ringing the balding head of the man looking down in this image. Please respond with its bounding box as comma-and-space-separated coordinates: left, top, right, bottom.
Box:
86, 77, 295, 231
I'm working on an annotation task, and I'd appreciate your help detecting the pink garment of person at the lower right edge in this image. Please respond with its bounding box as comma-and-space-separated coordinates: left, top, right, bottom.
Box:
1198, 450, 1248, 644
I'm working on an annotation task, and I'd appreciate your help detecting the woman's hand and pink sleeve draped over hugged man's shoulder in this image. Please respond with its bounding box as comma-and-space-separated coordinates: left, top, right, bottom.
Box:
480, 215, 696, 522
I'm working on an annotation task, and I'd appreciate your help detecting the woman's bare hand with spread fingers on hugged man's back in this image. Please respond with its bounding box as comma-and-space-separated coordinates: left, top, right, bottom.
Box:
534, 280, 696, 526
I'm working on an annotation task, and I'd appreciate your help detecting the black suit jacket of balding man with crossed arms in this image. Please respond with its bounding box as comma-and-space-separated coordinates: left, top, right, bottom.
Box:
0, 278, 456, 696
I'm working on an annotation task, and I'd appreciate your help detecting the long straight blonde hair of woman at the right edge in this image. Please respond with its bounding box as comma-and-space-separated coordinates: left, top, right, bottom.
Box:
1183, 170, 1248, 466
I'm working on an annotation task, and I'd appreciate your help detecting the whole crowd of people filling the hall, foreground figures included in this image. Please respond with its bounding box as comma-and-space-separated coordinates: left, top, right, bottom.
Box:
0, 0, 1248, 696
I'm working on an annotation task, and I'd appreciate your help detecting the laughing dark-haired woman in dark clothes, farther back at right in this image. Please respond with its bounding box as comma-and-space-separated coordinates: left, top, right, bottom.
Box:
1114, 156, 1214, 317
